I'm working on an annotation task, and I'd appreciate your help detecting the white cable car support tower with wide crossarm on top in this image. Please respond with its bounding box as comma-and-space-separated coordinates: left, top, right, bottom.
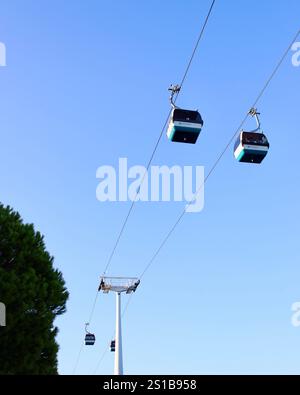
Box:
99, 276, 140, 375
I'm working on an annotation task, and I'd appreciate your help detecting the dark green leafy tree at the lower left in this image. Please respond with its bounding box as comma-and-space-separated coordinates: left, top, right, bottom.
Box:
0, 204, 68, 374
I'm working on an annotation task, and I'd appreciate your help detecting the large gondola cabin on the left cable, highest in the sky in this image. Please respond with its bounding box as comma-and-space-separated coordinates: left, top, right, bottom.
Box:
167, 108, 203, 144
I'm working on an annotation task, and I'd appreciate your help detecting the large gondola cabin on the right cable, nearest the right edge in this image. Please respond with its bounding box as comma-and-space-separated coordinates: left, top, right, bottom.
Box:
234, 131, 270, 163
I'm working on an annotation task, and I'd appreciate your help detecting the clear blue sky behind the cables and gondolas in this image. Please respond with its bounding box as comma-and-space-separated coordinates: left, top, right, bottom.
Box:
0, 0, 300, 374
